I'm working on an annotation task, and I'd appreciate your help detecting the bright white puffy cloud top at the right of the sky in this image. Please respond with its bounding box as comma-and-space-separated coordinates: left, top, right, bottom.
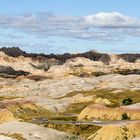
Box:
84, 12, 140, 28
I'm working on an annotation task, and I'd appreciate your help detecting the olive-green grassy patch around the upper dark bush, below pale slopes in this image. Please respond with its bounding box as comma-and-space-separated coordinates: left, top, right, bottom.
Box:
58, 90, 140, 114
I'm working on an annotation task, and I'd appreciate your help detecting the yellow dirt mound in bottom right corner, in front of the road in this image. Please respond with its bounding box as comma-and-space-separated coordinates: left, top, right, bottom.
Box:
88, 123, 140, 140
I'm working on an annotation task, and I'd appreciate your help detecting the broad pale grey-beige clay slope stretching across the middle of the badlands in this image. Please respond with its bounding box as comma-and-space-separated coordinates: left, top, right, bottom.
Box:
0, 74, 140, 112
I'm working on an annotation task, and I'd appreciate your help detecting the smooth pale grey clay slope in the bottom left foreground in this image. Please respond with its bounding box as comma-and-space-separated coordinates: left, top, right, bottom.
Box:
0, 121, 80, 140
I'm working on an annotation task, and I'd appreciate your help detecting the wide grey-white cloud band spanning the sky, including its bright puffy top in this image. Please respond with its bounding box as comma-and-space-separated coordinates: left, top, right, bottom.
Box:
0, 12, 140, 41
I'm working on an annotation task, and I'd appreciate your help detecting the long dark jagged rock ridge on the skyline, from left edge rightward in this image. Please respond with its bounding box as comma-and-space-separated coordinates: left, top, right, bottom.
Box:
0, 47, 110, 65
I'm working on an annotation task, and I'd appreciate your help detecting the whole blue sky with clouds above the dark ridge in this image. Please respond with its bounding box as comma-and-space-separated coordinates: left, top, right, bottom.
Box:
0, 0, 140, 54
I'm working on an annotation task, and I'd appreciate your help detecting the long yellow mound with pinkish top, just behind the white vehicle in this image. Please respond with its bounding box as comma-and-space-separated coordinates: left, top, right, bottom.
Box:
78, 104, 140, 120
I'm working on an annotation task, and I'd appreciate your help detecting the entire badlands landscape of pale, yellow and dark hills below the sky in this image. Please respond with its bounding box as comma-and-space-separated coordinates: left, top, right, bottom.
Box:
0, 48, 140, 140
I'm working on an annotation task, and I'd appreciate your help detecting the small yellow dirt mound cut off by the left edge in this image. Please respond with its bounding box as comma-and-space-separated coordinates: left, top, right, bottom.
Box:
0, 109, 16, 123
